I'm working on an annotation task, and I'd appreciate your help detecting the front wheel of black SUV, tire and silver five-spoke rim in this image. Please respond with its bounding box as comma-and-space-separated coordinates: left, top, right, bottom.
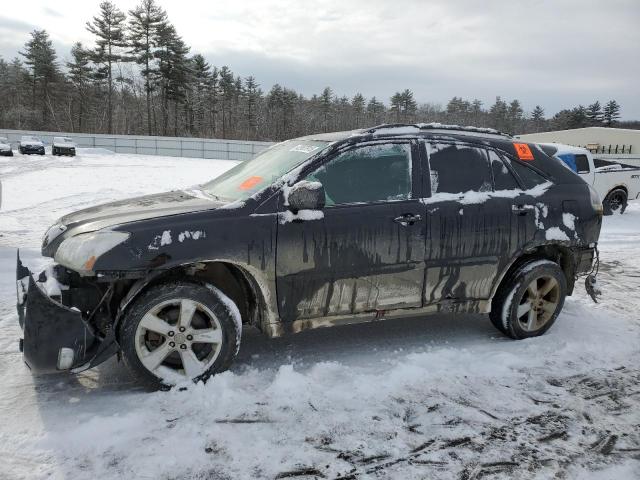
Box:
119, 282, 241, 390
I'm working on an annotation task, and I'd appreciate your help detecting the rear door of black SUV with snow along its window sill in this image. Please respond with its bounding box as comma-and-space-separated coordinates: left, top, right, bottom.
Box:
425, 142, 533, 304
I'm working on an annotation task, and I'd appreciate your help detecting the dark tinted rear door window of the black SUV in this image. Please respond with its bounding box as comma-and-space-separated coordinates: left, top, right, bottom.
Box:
429, 144, 492, 195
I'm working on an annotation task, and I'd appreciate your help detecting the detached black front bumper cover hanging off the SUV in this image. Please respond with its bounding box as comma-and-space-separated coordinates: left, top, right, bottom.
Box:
16, 253, 119, 373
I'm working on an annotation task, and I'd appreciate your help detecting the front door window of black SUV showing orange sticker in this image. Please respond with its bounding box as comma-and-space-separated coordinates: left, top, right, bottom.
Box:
307, 144, 411, 205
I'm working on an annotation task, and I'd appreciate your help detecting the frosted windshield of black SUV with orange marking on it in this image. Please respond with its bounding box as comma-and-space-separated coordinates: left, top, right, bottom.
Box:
202, 140, 330, 201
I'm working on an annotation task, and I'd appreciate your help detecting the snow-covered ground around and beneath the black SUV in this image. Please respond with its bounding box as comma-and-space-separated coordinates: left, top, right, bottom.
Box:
0, 154, 640, 480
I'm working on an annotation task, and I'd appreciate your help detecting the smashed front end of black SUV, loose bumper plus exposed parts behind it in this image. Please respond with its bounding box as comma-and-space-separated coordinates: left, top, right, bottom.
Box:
16, 253, 119, 373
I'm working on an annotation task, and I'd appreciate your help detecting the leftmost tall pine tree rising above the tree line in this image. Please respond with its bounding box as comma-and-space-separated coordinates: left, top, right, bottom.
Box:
20, 30, 60, 128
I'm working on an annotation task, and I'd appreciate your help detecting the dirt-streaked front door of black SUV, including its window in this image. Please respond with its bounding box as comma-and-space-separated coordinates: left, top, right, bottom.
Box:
276, 141, 425, 321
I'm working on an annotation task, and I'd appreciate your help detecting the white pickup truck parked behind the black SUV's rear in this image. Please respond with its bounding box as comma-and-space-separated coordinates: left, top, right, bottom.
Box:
540, 143, 640, 215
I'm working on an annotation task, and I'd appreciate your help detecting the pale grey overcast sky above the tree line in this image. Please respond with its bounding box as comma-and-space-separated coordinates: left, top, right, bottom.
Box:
0, 0, 640, 119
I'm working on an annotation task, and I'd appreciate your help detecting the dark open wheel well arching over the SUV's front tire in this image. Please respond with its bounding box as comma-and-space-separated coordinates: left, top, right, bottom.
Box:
120, 262, 264, 328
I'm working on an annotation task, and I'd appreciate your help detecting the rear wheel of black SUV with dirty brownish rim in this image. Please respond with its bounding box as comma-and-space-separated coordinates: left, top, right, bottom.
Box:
489, 260, 567, 340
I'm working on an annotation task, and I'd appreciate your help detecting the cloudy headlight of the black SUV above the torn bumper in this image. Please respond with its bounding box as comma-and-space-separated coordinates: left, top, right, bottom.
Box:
54, 230, 129, 274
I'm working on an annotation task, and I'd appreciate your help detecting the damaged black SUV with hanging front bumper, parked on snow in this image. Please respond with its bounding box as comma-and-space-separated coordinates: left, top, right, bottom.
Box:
17, 124, 602, 387
